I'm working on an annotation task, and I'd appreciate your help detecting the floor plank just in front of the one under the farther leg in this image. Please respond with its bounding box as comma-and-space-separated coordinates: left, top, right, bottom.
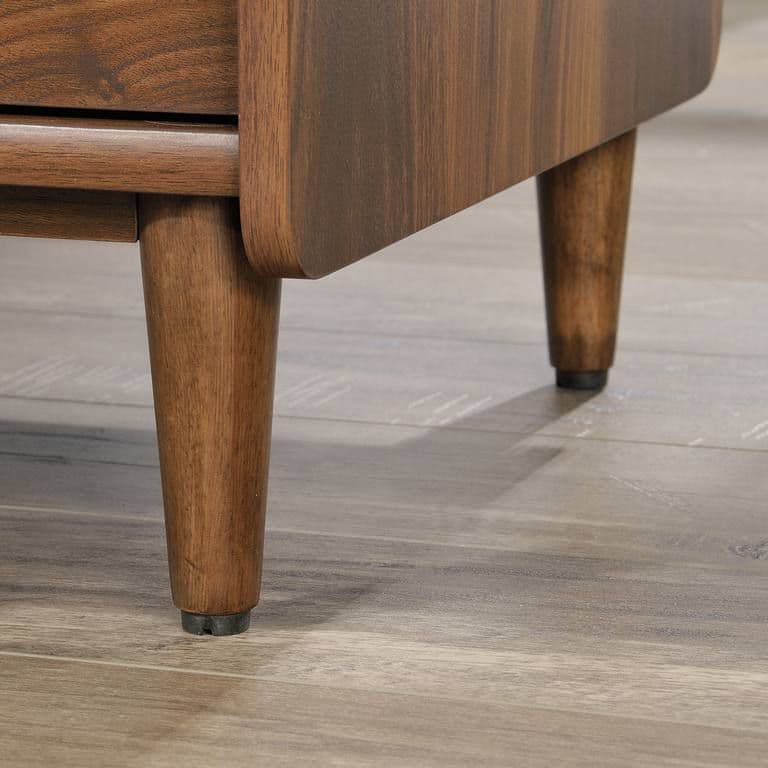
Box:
0, 414, 768, 567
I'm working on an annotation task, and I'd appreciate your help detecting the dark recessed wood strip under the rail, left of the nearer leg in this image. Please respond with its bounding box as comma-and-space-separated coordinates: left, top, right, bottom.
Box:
0, 186, 137, 243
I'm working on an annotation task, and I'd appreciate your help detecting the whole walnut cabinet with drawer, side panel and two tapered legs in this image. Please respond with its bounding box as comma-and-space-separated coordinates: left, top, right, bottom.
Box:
0, 0, 721, 634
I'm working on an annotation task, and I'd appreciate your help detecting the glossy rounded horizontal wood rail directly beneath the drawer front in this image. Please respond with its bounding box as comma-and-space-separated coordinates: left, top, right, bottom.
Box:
0, 115, 239, 196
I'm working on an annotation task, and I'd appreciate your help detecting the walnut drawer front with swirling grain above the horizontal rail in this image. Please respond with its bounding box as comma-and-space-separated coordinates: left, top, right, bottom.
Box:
0, 0, 237, 115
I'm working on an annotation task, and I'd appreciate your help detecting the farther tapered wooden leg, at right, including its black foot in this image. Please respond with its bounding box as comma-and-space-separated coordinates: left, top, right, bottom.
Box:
538, 131, 636, 389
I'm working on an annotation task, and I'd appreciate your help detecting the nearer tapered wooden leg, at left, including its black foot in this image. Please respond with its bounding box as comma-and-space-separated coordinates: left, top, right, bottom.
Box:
139, 195, 280, 635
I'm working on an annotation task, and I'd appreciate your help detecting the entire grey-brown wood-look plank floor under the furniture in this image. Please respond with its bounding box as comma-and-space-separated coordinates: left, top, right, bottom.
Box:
0, 0, 768, 768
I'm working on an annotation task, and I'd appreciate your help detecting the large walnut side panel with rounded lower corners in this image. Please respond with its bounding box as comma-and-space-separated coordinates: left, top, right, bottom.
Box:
240, 0, 721, 277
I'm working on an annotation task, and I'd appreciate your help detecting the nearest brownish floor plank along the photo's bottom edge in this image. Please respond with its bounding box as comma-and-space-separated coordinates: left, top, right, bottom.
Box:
6, 657, 766, 768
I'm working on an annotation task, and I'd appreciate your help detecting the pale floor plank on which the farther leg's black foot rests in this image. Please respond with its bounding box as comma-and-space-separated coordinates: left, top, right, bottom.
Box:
0, 313, 768, 450
